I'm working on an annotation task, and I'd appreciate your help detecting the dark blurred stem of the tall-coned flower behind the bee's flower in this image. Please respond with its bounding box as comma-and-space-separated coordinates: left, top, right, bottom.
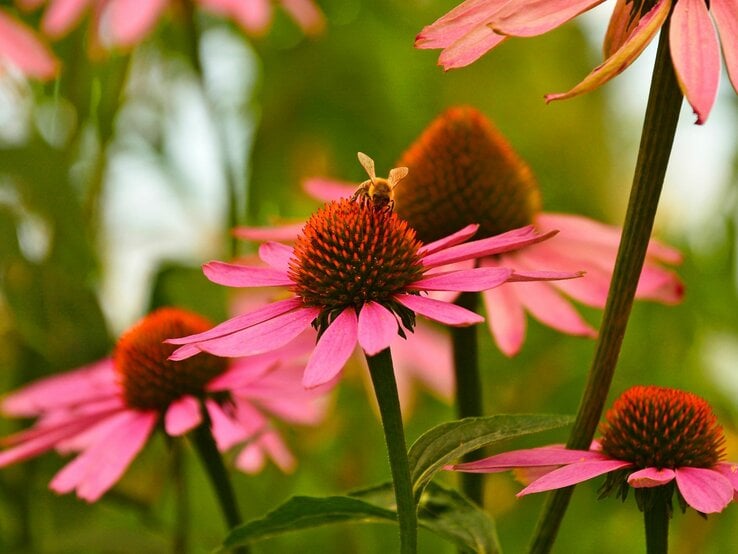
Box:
451, 292, 484, 506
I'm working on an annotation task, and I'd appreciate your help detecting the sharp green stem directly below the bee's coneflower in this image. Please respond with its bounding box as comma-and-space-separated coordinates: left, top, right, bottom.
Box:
366, 348, 418, 554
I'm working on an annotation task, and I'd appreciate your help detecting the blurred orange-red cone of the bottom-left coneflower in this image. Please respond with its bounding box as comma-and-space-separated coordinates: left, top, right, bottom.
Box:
113, 308, 227, 411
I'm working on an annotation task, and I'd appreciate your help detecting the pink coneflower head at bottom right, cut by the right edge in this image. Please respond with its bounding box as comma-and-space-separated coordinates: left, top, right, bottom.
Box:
446, 386, 738, 514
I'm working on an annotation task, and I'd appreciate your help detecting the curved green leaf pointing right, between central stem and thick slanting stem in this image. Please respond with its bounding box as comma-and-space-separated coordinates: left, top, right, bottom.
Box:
408, 414, 573, 498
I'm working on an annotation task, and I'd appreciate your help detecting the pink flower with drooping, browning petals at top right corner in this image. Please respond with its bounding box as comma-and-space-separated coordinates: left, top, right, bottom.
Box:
415, 0, 738, 124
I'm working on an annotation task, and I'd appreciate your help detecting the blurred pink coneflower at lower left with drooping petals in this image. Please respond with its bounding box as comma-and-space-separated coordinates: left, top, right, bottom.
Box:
0, 308, 322, 502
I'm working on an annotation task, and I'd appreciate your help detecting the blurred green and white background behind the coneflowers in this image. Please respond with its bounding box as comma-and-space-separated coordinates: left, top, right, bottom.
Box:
0, 0, 738, 554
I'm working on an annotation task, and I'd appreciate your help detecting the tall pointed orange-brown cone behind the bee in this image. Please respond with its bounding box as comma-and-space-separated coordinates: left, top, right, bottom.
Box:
394, 107, 541, 242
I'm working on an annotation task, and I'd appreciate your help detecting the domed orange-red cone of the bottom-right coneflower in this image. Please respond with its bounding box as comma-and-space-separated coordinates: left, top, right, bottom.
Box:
600, 386, 725, 469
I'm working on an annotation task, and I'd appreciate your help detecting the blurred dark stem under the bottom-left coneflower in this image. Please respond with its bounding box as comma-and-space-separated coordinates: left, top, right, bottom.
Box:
190, 415, 249, 554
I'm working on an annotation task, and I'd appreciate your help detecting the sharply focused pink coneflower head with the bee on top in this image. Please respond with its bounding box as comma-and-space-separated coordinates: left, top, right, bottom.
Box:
169, 188, 578, 387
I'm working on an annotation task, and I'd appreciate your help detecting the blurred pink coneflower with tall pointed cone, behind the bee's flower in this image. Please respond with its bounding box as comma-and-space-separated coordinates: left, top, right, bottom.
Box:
286, 107, 684, 356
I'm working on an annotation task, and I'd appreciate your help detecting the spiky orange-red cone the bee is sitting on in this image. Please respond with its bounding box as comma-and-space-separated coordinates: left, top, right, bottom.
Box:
289, 199, 423, 328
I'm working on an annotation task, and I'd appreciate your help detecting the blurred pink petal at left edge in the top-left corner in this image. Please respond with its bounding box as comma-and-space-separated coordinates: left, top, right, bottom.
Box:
0, 10, 59, 80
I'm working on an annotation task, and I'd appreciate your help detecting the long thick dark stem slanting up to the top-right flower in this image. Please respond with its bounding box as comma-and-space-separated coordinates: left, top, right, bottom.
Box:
530, 19, 682, 553
